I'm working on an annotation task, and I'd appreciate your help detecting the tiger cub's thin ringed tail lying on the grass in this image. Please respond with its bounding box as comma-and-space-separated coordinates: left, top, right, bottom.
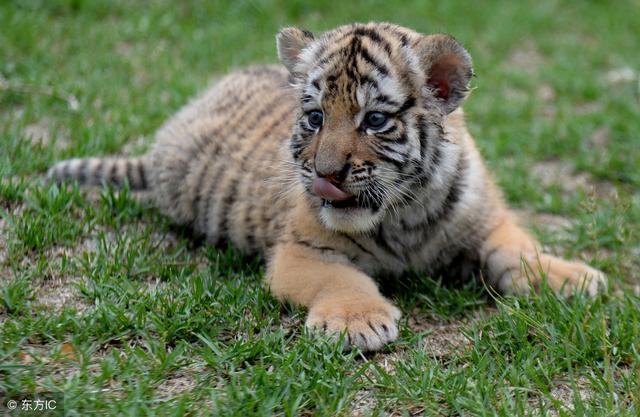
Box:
47, 156, 151, 190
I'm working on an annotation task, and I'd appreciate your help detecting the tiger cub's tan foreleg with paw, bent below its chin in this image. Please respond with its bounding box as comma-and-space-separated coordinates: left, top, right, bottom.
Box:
267, 243, 400, 350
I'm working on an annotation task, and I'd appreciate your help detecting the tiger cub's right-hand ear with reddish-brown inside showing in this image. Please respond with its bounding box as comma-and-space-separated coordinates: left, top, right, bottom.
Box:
420, 34, 473, 114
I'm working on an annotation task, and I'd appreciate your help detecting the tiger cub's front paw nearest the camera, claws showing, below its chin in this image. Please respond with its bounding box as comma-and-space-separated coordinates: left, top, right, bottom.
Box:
306, 296, 400, 351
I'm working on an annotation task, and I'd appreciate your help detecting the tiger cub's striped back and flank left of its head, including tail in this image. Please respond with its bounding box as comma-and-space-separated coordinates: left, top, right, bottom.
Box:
48, 66, 298, 253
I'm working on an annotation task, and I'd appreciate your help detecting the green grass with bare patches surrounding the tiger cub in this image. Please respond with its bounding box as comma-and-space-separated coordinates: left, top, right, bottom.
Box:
0, 0, 640, 416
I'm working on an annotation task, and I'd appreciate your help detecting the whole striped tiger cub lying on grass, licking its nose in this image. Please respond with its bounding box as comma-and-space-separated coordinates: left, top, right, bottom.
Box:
48, 23, 606, 350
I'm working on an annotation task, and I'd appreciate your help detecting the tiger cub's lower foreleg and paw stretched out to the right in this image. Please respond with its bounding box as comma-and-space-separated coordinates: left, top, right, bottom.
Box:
480, 214, 606, 296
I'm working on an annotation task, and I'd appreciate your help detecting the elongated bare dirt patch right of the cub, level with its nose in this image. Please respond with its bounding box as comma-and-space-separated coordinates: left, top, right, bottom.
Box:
532, 160, 618, 198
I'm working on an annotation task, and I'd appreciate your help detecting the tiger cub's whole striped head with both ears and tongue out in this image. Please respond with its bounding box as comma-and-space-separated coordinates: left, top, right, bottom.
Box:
277, 23, 472, 233
